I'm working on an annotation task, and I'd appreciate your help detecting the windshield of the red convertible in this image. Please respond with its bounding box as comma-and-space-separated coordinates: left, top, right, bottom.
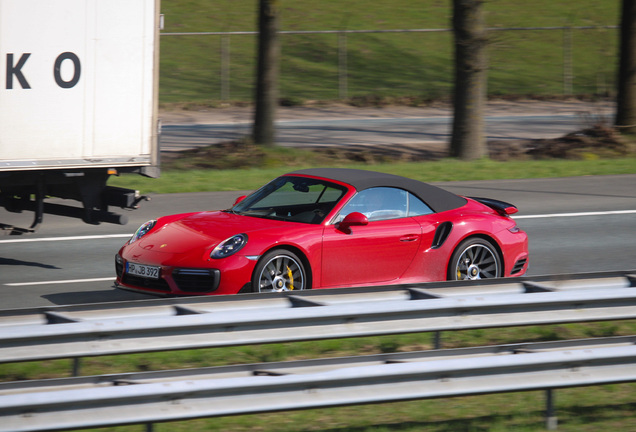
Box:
230, 176, 347, 224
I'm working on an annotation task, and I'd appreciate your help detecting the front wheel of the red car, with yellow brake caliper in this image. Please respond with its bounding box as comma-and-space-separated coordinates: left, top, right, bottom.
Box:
252, 249, 307, 292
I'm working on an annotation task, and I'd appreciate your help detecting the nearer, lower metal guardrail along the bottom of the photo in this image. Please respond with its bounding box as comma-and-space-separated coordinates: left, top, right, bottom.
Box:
0, 336, 636, 432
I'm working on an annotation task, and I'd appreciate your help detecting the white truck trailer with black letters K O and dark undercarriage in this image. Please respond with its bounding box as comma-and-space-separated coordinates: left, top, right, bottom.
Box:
0, 0, 160, 234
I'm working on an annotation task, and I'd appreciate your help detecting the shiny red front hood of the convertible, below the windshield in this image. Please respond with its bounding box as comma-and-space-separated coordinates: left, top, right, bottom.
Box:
135, 211, 288, 254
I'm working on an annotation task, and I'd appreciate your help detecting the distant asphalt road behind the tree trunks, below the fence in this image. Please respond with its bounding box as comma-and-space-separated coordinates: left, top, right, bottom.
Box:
161, 115, 585, 151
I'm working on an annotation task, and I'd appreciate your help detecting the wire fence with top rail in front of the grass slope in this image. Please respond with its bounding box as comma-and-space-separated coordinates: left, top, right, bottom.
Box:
161, 26, 618, 103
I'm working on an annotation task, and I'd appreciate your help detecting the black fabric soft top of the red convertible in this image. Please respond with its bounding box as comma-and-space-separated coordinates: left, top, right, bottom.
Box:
288, 168, 466, 213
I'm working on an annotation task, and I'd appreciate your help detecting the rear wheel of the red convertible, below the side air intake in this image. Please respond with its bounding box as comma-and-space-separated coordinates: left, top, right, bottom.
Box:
448, 237, 503, 280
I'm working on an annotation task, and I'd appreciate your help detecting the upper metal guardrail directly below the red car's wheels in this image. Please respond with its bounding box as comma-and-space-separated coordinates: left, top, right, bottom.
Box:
0, 273, 636, 363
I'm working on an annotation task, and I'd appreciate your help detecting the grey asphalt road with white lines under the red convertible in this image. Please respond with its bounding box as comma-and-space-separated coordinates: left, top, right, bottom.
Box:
0, 175, 636, 309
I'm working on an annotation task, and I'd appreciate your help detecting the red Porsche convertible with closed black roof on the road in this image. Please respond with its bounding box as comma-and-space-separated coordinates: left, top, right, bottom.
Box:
115, 168, 528, 295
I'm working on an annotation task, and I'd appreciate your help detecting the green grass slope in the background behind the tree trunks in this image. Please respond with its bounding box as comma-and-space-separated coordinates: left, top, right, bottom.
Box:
160, 0, 620, 105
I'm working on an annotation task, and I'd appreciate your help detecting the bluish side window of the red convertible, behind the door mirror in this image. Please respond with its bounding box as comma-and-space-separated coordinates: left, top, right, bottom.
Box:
338, 187, 408, 221
